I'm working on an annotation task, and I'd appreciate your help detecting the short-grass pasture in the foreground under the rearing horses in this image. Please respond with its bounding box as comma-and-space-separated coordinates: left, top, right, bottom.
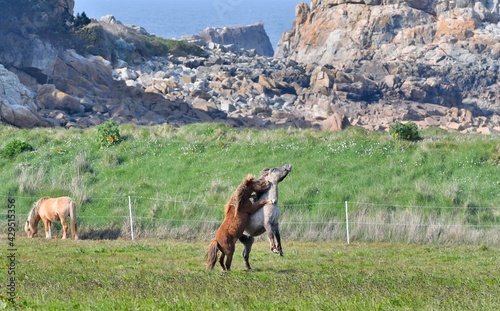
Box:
0, 236, 500, 310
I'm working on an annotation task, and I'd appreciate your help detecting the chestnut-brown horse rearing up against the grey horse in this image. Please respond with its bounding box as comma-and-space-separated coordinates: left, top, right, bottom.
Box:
207, 175, 270, 271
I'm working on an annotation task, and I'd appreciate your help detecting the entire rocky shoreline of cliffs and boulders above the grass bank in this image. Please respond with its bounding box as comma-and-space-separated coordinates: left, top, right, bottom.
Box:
0, 0, 500, 133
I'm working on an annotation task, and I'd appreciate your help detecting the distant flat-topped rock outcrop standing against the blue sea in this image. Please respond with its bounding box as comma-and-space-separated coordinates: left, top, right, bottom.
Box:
200, 23, 274, 56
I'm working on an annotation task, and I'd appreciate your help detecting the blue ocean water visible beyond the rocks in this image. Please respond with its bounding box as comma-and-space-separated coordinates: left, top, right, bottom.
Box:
74, 0, 303, 48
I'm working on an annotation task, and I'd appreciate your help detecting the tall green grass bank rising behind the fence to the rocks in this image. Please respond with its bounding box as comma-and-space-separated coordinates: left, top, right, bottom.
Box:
0, 124, 500, 244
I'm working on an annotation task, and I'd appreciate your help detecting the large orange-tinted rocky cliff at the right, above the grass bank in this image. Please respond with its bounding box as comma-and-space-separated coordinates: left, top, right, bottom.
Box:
275, 0, 500, 133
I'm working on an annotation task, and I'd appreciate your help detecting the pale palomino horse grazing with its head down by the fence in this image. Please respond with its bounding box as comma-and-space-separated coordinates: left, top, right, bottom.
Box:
24, 197, 78, 240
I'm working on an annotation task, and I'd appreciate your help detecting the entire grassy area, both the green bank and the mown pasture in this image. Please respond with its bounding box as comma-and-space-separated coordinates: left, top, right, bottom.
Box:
0, 124, 500, 310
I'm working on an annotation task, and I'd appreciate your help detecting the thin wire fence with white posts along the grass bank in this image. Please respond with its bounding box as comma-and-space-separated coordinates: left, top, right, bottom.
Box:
0, 196, 500, 244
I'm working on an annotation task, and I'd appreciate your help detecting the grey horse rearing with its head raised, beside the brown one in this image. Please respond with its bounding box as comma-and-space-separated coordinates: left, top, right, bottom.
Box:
240, 164, 292, 269
